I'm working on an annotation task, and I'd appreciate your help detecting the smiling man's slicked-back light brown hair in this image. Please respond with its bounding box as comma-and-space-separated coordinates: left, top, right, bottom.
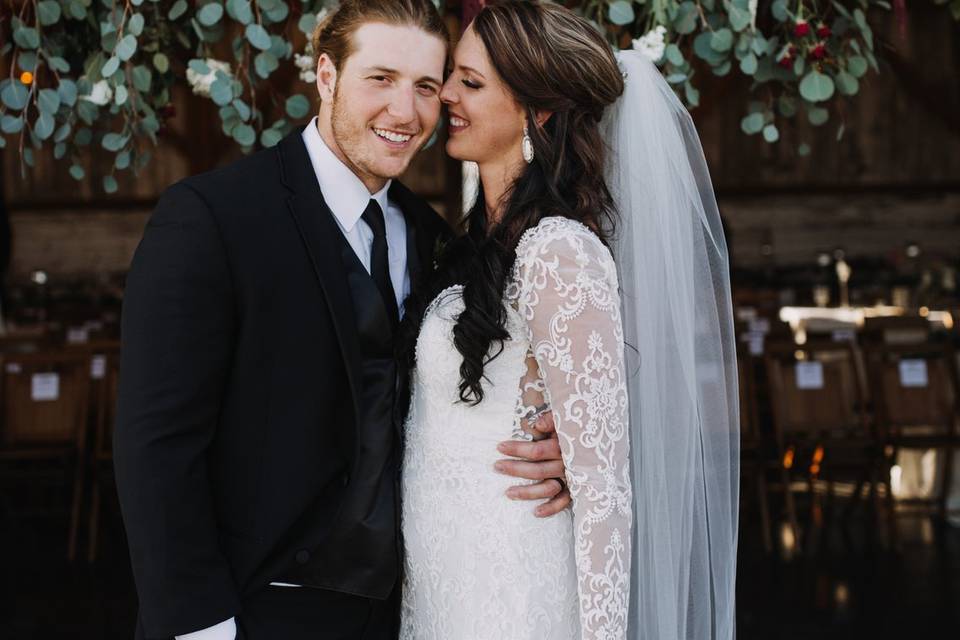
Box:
311, 0, 450, 72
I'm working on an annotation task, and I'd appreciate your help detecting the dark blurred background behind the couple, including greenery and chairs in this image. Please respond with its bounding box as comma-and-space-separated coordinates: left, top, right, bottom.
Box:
0, 0, 960, 639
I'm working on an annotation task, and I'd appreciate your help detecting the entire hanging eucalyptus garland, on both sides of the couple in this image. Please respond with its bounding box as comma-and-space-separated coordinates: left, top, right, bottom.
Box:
0, 0, 948, 193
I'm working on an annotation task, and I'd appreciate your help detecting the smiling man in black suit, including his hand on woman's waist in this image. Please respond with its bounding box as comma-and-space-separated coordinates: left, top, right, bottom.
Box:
115, 0, 569, 640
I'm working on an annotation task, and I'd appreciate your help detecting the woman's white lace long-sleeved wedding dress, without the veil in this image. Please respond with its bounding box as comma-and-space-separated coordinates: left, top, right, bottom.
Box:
400, 217, 631, 640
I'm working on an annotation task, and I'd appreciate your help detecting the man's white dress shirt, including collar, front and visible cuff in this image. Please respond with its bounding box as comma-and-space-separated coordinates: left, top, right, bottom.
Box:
176, 116, 410, 640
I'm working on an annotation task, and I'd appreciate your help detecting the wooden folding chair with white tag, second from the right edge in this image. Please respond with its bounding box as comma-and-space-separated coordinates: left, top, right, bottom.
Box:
765, 341, 879, 556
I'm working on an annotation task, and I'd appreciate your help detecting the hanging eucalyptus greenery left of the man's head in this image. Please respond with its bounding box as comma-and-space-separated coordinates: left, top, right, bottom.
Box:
0, 0, 336, 193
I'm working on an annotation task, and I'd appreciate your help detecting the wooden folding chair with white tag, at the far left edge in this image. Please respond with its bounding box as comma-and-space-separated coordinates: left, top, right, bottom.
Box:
0, 352, 90, 561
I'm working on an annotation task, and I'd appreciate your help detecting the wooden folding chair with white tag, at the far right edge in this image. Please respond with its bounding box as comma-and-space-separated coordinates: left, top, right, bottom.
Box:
866, 341, 960, 526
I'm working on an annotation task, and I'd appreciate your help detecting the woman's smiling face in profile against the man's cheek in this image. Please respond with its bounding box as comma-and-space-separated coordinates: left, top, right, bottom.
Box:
440, 28, 523, 165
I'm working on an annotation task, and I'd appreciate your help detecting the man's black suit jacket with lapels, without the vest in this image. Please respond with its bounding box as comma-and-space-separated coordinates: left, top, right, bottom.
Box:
115, 131, 449, 638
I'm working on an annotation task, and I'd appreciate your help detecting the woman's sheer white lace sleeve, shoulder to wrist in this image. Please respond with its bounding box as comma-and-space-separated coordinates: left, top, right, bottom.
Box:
507, 218, 632, 640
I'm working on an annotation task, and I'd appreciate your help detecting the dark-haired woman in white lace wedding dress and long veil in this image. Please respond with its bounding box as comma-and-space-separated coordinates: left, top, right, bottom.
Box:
400, 1, 738, 640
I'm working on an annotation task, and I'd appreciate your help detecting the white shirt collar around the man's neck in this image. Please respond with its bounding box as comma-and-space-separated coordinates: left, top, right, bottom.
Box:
303, 116, 392, 233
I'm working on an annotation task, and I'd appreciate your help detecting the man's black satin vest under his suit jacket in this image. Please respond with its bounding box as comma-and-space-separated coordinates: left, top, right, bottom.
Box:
280, 205, 419, 599
